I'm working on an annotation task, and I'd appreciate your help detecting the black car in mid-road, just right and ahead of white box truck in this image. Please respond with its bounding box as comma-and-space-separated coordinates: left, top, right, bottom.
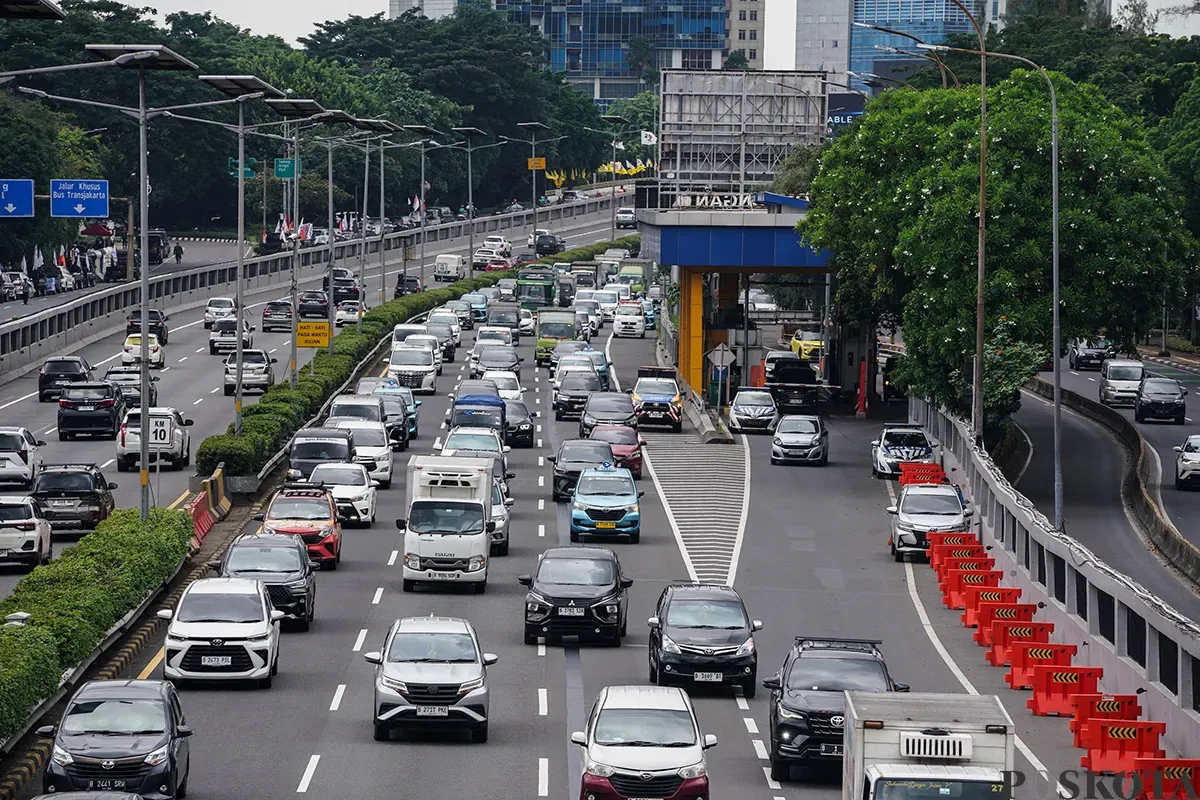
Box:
517, 547, 634, 646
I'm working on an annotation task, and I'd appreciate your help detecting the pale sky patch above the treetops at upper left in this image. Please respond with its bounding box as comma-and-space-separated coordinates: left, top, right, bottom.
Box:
134, 0, 388, 44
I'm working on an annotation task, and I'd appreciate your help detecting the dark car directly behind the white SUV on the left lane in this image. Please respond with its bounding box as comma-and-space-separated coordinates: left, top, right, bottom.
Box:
208, 537, 319, 631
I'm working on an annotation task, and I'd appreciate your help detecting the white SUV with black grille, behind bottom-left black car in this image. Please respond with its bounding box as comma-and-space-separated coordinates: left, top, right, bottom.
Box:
158, 578, 284, 688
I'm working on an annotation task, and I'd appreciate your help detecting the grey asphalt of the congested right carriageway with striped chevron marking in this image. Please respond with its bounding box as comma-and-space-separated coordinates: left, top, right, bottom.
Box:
23, 331, 1078, 800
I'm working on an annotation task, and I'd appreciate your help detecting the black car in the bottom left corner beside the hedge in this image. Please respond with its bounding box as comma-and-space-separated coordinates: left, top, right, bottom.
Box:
37, 680, 192, 800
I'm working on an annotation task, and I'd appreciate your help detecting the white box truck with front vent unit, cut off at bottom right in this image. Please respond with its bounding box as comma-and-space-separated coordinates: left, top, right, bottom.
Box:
841, 692, 1015, 800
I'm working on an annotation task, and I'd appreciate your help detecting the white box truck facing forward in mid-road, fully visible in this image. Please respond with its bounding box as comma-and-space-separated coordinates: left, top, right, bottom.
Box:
396, 456, 496, 594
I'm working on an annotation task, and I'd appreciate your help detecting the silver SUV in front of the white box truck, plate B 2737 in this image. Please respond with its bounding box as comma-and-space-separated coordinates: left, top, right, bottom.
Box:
364, 616, 497, 742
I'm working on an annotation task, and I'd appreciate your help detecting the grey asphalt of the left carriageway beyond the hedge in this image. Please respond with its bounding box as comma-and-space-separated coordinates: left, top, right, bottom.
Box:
0, 212, 608, 596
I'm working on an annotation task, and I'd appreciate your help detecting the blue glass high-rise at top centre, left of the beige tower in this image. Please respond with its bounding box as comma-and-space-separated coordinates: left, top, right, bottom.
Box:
482, 0, 724, 108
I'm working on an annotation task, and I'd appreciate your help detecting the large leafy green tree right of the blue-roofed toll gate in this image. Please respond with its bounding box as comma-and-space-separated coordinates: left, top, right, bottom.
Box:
802, 71, 1193, 425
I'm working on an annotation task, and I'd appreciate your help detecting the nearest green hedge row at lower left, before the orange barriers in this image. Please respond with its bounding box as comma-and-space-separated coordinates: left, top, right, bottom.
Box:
0, 509, 193, 740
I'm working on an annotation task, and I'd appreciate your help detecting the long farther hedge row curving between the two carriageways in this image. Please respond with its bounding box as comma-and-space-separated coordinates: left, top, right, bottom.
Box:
196, 272, 512, 475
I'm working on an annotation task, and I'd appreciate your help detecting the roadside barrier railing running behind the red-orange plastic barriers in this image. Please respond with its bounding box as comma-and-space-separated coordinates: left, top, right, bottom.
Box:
908, 398, 1200, 756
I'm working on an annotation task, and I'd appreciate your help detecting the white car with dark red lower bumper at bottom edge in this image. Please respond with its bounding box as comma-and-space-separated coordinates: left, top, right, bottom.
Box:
571, 686, 716, 798
